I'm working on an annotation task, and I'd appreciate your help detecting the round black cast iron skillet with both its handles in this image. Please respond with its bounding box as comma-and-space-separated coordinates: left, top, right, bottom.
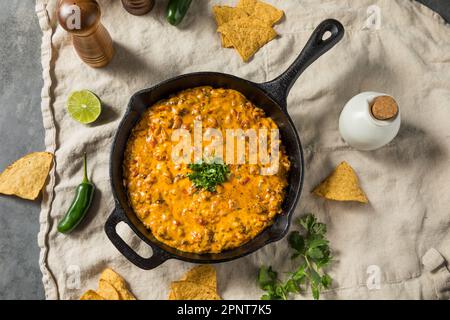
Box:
105, 19, 344, 270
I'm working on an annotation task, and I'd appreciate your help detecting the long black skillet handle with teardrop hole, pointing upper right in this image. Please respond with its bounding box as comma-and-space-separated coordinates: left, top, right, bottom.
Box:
259, 19, 345, 111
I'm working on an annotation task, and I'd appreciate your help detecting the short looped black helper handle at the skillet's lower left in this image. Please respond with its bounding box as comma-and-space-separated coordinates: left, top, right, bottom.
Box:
105, 207, 170, 270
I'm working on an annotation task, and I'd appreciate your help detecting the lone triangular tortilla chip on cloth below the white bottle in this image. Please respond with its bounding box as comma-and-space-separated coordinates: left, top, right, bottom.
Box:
313, 162, 369, 203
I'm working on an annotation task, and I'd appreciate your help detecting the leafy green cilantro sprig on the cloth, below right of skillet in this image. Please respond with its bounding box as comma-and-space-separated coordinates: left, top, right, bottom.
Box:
258, 214, 332, 300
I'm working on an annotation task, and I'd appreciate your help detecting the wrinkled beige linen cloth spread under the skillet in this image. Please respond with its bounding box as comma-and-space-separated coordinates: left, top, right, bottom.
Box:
36, 0, 450, 299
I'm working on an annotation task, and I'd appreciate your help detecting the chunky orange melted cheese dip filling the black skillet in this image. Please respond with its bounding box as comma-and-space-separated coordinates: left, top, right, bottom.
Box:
123, 87, 290, 253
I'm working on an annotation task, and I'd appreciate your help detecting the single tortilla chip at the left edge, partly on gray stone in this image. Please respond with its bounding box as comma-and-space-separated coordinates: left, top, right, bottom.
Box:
0, 152, 53, 200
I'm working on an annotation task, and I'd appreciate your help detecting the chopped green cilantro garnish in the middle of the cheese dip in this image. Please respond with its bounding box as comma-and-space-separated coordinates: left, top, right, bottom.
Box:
187, 161, 230, 192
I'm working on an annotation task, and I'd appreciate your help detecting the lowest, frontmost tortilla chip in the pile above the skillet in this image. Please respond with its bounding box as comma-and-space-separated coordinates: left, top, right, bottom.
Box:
218, 18, 277, 61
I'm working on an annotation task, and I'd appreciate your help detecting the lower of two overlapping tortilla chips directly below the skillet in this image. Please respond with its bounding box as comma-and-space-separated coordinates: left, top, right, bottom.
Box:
170, 281, 221, 300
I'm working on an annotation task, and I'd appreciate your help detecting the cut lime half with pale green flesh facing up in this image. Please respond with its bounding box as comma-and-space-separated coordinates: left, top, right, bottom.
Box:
67, 90, 102, 124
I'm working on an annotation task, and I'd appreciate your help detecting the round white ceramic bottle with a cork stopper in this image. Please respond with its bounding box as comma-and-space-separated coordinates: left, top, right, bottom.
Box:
339, 92, 401, 151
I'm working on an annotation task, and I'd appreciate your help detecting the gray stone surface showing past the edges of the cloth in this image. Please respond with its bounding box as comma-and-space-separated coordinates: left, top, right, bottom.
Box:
0, 0, 450, 299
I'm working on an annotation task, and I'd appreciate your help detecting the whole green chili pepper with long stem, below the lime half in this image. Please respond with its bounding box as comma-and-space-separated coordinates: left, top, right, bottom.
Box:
58, 153, 95, 233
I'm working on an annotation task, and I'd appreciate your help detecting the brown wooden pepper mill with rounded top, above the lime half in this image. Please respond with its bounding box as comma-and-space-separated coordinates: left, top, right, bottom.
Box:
57, 0, 114, 68
